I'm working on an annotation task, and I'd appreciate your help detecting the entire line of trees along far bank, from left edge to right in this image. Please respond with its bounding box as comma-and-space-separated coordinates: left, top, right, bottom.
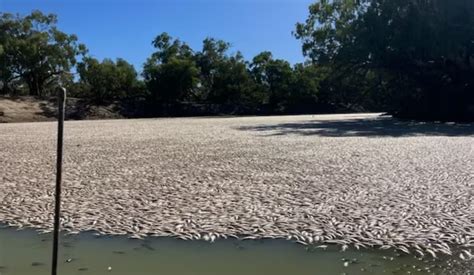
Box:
0, 0, 474, 121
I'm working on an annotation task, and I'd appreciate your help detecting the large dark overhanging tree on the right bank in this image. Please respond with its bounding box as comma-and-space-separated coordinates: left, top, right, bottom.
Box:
296, 0, 474, 119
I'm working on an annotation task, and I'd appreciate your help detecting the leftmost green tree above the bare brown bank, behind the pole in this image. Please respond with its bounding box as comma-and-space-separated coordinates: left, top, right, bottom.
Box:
0, 11, 86, 96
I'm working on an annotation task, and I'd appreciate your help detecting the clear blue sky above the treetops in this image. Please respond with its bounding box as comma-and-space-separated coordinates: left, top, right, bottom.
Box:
0, 0, 314, 70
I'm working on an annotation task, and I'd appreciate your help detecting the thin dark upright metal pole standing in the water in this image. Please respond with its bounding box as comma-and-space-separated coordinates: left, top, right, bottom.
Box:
51, 87, 66, 275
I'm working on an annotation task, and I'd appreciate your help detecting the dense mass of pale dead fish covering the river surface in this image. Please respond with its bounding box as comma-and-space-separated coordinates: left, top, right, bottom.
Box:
0, 114, 474, 259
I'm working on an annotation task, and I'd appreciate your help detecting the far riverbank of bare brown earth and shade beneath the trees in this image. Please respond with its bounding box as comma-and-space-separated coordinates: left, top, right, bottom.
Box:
0, 96, 361, 123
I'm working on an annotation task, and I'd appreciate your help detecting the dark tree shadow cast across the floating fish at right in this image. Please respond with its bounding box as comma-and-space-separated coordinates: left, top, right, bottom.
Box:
237, 116, 474, 137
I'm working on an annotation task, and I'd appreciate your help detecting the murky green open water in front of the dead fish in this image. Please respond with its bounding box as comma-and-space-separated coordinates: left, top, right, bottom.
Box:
0, 228, 472, 275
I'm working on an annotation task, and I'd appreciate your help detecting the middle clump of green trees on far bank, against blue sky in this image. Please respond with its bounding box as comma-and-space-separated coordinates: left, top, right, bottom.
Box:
143, 33, 320, 112
